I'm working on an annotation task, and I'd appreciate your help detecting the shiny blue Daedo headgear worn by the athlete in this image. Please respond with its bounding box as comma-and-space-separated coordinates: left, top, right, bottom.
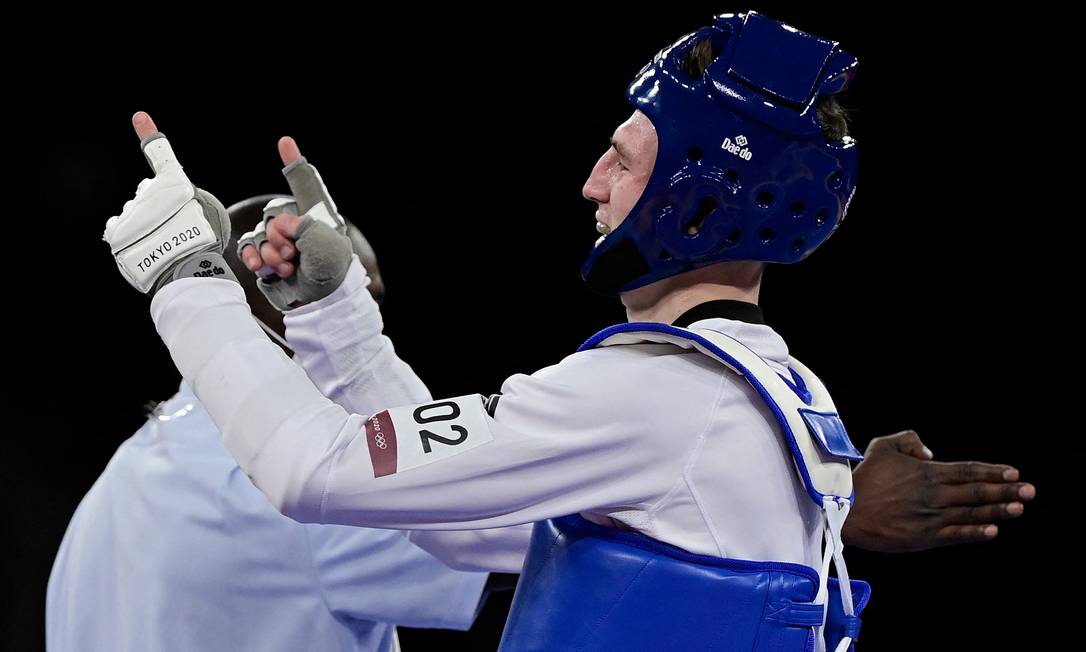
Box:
581, 11, 857, 294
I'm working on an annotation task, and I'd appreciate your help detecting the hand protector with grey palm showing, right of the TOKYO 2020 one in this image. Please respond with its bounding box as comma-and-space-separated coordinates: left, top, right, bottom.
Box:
238, 156, 352, 312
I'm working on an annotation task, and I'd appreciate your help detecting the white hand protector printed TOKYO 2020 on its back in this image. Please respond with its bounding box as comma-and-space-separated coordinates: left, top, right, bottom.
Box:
102, 133, 237, 294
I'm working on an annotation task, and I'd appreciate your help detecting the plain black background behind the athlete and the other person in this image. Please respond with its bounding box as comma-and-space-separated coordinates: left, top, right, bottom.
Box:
2, 2, 1051, 650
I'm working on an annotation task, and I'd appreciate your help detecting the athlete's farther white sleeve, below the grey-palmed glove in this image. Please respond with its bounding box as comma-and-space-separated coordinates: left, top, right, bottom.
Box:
283, 256, 431, 414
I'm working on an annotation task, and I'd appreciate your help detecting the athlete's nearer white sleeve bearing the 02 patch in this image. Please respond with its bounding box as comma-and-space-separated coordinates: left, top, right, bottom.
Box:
151, 278, 686, 529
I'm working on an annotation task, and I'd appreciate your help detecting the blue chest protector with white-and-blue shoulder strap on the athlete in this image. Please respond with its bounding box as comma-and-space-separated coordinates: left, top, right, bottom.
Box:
501, 324, 871, 652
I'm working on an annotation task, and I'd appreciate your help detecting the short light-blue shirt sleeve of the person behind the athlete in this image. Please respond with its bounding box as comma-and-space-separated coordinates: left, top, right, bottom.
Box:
306, 526, 488, 629
